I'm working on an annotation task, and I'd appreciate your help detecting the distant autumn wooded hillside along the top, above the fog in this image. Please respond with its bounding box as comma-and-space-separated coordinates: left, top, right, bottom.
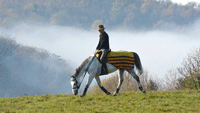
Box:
0, 0, 200, 29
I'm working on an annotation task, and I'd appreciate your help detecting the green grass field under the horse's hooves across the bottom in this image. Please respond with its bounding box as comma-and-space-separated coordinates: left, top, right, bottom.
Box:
0, 90, 200, 113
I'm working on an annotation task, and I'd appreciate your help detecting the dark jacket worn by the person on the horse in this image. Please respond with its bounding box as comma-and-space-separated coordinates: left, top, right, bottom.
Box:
96, 31, 110, 50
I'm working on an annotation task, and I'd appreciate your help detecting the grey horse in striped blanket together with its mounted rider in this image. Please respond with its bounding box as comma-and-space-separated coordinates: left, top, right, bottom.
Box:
71, 25, 145, 97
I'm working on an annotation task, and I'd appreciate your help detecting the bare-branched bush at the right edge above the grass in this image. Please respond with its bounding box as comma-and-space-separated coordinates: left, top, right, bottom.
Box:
165, 48, 200, 90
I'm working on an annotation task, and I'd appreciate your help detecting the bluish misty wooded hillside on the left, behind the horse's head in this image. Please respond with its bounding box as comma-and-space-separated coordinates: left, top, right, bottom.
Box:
0, 36, 72, 97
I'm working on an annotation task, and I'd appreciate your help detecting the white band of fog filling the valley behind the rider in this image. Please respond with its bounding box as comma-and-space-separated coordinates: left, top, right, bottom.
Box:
0, 21, 200, 96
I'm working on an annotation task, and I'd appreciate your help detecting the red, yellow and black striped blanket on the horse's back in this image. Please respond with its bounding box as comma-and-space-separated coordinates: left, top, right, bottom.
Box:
96, 51, 135, 69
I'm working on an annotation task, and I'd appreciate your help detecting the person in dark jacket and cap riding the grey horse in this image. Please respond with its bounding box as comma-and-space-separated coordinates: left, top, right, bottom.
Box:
94, 25, 110, 73
